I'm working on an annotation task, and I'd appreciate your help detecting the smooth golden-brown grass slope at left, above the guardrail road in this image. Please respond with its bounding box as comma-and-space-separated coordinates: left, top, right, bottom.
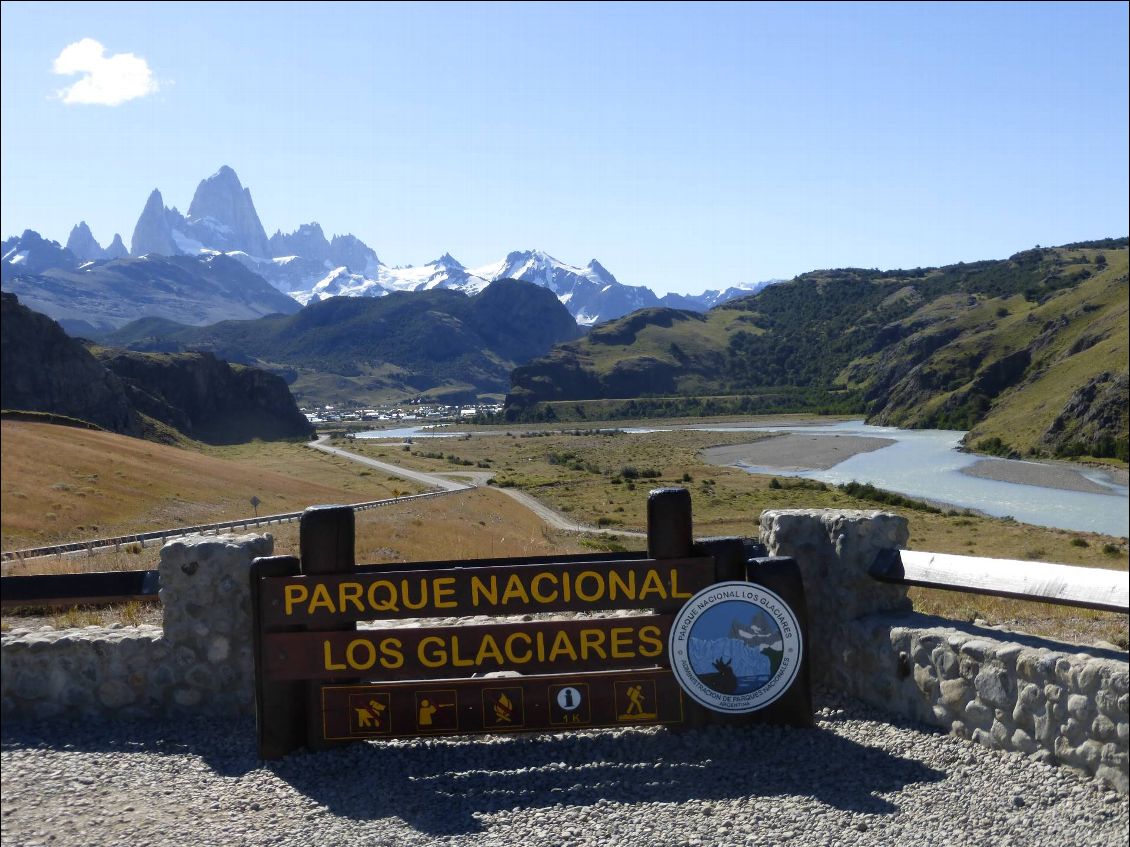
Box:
0, 420, 420, 550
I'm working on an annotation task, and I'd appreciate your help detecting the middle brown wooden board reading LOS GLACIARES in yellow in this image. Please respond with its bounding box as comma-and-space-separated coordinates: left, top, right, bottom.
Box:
261, 614, 672, 682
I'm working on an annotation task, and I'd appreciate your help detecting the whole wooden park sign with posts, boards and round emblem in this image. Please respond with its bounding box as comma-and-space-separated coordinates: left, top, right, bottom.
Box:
251, 489, 812, 759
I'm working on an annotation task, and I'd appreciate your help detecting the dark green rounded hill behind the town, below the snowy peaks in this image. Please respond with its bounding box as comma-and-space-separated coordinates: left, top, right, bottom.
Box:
101, 280, 580, 404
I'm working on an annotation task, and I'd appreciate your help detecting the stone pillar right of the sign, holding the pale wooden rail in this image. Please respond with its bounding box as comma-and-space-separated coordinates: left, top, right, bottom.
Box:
760, 509, 911, 691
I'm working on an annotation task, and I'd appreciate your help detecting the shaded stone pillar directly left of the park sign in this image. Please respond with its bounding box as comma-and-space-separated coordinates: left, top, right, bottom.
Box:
159, 535, 275, 715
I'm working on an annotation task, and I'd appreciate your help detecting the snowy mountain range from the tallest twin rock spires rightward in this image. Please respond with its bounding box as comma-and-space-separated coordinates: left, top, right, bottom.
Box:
121, 165, 777, 325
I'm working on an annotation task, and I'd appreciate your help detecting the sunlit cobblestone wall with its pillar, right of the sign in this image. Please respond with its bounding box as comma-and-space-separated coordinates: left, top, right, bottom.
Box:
760, 509, 1130, 793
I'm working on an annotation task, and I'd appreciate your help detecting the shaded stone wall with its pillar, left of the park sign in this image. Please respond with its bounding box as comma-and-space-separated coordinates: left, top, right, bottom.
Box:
0, 535, 273, 721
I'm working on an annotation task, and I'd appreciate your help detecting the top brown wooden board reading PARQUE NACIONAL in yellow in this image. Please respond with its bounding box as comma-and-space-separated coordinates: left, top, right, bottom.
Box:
258, 557, 715, 628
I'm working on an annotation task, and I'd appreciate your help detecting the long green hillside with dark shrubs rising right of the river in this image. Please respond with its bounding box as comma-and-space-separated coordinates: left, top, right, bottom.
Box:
507, 238, 1128, 461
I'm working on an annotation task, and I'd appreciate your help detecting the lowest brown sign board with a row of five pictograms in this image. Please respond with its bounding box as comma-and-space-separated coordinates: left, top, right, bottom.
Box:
321, 670, 687, 741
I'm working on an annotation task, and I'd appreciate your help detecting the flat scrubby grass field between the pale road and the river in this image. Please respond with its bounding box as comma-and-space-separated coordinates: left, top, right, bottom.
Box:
349, 428, 1130, 646
